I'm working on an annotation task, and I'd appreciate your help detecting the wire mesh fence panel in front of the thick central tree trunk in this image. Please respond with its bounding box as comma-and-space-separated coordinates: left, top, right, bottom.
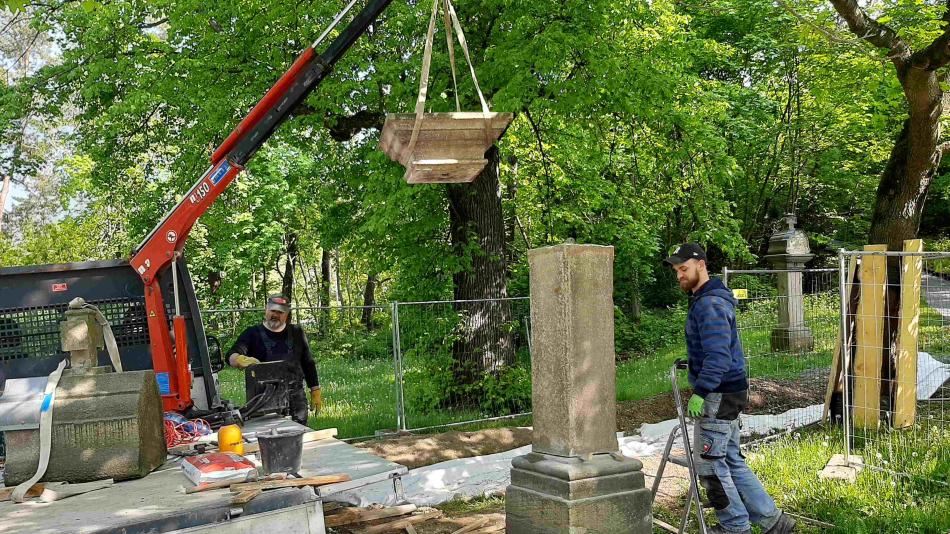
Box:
395, 298, 531, 430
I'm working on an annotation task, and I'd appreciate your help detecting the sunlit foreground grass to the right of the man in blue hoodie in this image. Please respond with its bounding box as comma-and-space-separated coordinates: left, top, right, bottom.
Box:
749, 427, 950, 533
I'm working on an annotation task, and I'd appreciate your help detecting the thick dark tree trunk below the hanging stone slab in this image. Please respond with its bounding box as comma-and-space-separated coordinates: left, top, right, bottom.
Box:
446, 147, 515, 390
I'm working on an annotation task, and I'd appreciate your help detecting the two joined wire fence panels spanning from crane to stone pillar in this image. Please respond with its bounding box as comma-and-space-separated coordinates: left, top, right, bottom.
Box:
202, 298, 531, 437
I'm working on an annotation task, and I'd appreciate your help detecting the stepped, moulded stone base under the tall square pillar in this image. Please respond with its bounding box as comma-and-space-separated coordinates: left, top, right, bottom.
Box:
505, 452, 653, 534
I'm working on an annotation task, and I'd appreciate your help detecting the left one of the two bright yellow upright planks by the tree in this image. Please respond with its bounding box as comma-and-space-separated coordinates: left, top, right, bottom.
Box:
851, 245, 887, 429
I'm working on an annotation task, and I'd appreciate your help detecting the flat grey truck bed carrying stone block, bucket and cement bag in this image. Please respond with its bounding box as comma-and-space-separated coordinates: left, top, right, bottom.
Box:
0, 417, 407, 534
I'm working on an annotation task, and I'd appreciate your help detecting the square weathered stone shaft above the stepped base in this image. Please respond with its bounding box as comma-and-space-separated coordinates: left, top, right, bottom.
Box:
528, 244, 617, 456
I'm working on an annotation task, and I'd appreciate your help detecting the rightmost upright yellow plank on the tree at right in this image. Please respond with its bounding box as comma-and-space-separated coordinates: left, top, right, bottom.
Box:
894, 239, 924, 428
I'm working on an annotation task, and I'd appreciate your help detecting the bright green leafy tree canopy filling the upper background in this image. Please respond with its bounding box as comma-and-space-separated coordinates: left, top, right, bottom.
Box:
0, 0, 950, 315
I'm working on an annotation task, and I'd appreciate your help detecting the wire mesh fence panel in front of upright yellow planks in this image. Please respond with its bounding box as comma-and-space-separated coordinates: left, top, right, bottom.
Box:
832, 249, 950, 497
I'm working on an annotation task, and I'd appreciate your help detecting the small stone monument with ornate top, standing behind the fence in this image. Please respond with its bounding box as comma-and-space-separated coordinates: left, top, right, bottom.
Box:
765, 213, 815, 353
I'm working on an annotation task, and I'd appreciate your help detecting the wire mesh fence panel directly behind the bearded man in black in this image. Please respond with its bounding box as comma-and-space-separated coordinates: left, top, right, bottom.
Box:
202, 306, 397, 438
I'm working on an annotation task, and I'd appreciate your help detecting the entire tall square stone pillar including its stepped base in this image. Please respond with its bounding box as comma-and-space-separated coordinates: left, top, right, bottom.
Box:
505, 244, 652, 534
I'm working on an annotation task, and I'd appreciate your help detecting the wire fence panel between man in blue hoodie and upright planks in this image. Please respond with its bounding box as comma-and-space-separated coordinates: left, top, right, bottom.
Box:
723, 269, 839, 435
